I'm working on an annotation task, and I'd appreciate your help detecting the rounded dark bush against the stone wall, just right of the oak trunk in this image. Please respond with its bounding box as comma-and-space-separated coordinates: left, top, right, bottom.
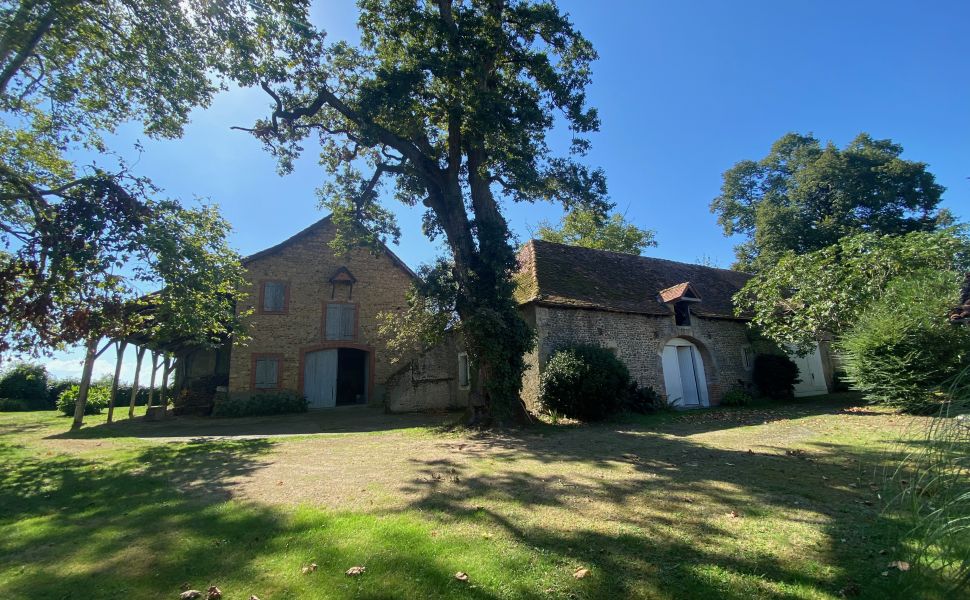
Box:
539, 345, 630, 421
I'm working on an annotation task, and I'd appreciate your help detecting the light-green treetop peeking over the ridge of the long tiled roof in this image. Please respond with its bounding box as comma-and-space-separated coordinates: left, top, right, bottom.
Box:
536, 208, 657, 254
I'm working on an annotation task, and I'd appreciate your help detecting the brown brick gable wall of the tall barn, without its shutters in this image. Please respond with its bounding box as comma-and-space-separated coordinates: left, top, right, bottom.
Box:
229, 222, 420, 404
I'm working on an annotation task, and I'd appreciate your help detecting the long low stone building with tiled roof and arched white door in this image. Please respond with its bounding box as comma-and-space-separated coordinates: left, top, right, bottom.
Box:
518, 240, 830, 408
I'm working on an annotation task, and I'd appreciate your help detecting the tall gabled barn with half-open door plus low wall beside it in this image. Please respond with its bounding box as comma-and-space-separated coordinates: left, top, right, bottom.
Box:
180, 217, 468, 411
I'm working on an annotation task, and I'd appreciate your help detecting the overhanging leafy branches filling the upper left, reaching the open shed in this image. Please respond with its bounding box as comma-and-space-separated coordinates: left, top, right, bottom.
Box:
0, 0, 308, 354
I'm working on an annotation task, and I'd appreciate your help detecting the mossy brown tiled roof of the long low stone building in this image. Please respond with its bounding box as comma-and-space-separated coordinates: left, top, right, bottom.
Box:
516, 240, 751, 318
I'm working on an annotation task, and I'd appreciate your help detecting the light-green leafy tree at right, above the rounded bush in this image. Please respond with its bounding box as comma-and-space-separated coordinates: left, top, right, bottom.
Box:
734, 229, 970, 349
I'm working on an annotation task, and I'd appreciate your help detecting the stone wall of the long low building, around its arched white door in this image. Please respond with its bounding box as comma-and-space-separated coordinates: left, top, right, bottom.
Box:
522, 304, 751, 408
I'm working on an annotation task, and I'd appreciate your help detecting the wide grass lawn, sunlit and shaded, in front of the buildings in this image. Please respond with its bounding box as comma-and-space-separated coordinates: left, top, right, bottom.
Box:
0, 396, 954, 600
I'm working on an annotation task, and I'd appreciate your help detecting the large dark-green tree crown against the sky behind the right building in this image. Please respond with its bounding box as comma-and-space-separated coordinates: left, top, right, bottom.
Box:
711, 133, 953, 272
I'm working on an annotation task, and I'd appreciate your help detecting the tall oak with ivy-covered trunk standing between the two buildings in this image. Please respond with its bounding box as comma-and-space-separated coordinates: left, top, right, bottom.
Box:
241, 0, 608, 419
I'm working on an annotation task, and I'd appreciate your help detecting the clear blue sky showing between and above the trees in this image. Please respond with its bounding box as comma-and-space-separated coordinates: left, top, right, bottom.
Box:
34, 0, 970, 377
